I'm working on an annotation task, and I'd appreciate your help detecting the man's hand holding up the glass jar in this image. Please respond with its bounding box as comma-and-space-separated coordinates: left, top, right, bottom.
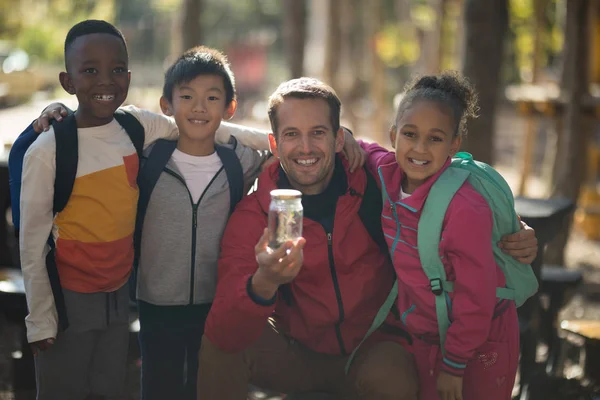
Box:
252, 229, 306, 299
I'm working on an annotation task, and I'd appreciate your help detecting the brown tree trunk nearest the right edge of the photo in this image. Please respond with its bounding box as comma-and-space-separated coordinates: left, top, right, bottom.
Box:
544, 0, 590, 265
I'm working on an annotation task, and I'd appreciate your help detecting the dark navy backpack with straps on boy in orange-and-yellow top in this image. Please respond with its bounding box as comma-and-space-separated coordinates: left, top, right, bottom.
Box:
9, 110, 145, 330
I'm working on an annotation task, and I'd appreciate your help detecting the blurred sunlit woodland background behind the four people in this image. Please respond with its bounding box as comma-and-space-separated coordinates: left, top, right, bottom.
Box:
0, 0, 600, 399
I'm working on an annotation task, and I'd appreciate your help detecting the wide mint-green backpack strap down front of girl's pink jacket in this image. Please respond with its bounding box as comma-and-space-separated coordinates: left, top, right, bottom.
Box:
417, 168, 470, 352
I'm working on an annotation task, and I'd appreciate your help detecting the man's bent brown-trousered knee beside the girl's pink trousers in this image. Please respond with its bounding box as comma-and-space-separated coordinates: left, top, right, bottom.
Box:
350, 342, 419, 400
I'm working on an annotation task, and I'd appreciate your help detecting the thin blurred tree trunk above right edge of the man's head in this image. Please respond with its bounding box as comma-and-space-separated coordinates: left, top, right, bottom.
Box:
323, 0, 342, 89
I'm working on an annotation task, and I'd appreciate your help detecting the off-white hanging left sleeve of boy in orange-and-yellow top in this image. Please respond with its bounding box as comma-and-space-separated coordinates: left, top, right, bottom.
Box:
19, 144, 58, 343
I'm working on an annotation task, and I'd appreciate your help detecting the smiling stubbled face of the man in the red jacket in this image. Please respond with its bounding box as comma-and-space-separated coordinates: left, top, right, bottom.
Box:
271, 98, 344, 195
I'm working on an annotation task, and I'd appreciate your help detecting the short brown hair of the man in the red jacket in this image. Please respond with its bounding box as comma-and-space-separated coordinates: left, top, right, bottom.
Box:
269, 78, 342, 137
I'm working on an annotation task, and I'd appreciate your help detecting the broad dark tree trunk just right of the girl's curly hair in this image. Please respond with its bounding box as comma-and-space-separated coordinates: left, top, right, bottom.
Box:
463, 0, 508, 164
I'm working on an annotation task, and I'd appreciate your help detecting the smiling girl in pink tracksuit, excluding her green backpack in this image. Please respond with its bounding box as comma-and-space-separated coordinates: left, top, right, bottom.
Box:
363, 73, 519, 400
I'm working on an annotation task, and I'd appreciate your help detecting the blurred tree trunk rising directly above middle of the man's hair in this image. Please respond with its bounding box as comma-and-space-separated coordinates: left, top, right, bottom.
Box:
283, 0, 307, 78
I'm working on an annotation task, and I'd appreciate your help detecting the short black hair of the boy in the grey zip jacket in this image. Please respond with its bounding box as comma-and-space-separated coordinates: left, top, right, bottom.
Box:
163, 46, 235, 106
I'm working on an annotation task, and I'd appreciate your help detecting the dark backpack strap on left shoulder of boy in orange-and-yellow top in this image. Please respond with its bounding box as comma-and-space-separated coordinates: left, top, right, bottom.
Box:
52, 114, 79, 214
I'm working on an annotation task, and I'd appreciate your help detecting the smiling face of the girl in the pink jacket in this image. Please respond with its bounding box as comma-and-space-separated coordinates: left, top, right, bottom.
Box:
390, 100, 461, 193
